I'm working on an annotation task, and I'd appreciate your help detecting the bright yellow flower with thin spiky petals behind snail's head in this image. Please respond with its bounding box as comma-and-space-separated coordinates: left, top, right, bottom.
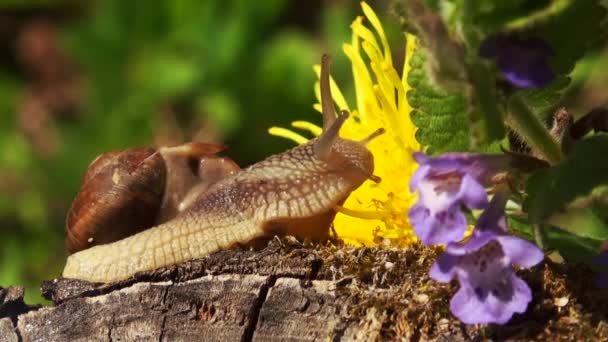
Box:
269, 2, 420, 245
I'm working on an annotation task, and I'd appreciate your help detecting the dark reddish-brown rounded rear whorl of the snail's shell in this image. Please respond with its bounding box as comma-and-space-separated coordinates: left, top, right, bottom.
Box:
66, 148, 167, 253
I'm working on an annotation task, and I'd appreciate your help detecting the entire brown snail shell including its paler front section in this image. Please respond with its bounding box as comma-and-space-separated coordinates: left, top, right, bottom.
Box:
66, 142, 240, 253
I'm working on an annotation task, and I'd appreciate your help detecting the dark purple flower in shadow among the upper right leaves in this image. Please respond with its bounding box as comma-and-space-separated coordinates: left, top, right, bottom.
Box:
479, 34, 555, 88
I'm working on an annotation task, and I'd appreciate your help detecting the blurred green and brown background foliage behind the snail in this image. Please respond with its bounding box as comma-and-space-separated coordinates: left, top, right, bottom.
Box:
0, 0, 608, 302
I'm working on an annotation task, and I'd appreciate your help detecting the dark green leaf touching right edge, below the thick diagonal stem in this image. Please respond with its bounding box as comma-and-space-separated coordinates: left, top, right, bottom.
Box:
524, 135, 608, 222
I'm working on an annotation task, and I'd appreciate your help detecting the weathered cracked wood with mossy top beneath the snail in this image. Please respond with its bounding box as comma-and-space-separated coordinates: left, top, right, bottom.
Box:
0, 238, 608, 341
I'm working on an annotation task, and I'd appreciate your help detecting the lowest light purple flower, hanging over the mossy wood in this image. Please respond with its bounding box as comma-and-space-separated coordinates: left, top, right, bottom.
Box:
430, 194, 543, 324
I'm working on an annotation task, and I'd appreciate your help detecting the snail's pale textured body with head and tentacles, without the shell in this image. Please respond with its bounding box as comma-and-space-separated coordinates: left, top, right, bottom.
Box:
63, 56, 384, 283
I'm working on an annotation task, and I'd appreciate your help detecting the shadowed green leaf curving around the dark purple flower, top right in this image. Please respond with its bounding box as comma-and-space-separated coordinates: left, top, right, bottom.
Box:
475, 0, 606, 118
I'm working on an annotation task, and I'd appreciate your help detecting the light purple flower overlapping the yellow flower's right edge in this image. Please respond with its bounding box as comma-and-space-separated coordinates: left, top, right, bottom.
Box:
408, 152, 508, 245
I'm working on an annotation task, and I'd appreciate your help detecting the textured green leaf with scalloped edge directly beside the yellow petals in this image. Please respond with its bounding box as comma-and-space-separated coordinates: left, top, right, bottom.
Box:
408, 48, 469, 154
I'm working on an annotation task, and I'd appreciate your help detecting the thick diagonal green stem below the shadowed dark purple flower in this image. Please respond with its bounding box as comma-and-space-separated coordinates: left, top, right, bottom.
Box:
506, 95, 563, 165
